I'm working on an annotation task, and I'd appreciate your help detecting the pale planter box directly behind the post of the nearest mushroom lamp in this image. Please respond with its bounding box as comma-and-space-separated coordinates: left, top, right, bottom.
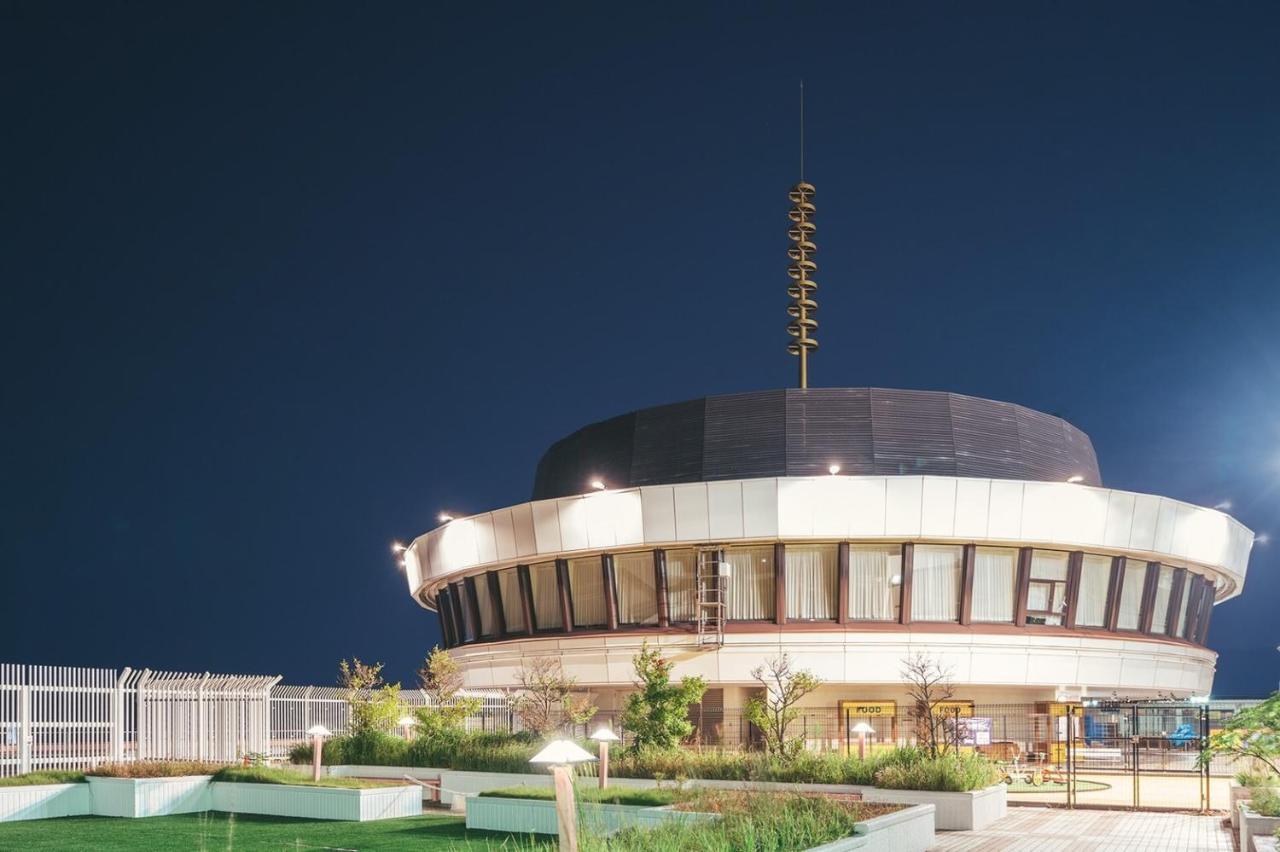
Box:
467, 796, 718, 834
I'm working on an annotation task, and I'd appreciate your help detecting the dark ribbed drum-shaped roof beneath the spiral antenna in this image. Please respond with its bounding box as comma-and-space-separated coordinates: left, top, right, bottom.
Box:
534, 388, 1102, 500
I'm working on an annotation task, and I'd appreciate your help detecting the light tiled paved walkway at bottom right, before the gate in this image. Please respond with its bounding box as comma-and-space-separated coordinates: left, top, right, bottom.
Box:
932, 807, 1234, 852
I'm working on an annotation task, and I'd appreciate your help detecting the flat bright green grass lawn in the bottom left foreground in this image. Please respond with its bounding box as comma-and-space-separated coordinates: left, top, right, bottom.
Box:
0, 812, 553, 852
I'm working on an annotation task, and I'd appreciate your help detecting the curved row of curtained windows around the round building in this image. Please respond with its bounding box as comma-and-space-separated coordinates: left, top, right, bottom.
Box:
436, 544, 1213, 645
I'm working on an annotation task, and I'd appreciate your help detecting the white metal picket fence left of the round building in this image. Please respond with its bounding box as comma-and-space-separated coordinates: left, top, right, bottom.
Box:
0, 664, 512, 778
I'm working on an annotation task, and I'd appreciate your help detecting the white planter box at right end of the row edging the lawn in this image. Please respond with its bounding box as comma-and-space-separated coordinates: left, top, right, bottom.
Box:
210, 782, 422, 823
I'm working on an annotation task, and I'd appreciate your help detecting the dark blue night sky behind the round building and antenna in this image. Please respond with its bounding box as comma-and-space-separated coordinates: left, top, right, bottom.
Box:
0, 3, 1280, 695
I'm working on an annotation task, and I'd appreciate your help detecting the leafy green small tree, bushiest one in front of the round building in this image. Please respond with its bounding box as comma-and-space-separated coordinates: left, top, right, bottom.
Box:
622, 642, 707, 751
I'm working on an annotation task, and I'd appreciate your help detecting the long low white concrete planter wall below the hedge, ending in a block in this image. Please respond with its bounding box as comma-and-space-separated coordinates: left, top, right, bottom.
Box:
329, 766, 1009, 832
